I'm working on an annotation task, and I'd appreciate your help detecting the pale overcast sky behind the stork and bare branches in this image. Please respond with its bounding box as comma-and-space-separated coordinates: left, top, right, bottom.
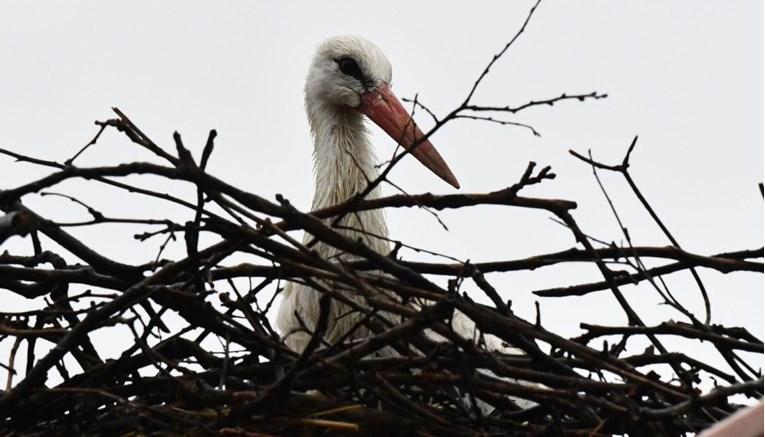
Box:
0, 0, 763, 384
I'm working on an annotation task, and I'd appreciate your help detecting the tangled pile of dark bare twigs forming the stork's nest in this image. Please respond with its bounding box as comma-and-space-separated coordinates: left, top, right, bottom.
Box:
0, 111, 763, 435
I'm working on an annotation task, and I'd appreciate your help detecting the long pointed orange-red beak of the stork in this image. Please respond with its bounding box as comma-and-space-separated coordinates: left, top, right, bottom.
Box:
358, 83, 460, 188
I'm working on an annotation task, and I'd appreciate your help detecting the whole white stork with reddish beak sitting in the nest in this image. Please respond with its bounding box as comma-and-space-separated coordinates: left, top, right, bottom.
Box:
277, 36, 459, 351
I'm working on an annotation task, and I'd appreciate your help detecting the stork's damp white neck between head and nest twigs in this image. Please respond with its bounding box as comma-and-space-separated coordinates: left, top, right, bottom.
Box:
306, 102, 390, 253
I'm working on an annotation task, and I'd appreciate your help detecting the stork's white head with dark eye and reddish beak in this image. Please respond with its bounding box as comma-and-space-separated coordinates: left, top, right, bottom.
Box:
305, 36, 459, 188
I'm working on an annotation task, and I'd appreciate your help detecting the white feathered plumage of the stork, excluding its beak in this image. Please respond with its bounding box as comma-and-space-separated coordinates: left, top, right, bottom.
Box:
277, 36, 391, 351
